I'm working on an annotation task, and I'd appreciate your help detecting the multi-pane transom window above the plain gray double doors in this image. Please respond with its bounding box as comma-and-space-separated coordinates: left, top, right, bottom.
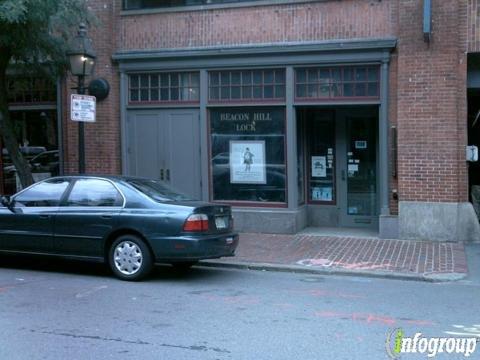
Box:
128, 72, 200, 104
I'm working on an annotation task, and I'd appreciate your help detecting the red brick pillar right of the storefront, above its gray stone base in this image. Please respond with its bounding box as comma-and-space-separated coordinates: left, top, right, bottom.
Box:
396, 0, 467, 202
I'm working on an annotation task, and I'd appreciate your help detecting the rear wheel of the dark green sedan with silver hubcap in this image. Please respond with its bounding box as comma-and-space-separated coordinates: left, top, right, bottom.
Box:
108, 235, 153, 281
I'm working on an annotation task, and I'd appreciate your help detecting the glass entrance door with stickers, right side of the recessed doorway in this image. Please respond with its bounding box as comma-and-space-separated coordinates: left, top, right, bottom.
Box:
336, 108, 378, 228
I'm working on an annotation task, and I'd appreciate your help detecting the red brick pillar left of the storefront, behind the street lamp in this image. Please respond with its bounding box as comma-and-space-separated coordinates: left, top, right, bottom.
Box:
63, 0, 121, 174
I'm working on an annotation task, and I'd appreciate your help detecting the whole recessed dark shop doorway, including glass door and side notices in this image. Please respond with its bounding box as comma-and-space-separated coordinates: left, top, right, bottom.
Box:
297, 106, 379, 229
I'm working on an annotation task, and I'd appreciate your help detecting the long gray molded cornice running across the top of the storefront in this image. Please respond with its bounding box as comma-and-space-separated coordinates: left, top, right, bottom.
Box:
113, 38, 396, 72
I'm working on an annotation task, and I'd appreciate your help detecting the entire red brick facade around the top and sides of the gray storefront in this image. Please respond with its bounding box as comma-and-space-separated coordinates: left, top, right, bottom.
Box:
65, 0, 470, 208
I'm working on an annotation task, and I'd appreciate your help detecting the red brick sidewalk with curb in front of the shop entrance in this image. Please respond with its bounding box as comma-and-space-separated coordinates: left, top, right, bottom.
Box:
202, 233, 468, 281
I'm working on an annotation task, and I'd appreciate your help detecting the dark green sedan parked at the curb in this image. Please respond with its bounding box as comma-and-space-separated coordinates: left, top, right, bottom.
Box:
0, 176, 238, 280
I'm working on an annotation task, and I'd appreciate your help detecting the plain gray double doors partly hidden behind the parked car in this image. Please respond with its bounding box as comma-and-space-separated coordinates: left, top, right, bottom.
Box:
126, 109, 201, 199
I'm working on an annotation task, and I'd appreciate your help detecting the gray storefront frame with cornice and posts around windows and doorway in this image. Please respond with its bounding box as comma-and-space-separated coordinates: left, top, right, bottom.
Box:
113, 38, 397, 233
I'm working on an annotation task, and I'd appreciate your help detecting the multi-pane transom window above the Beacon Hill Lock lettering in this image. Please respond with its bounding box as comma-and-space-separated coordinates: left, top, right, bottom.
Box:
208, 69, 285, 103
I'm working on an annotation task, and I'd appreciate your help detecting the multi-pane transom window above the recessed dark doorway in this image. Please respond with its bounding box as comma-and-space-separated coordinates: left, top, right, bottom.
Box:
295, 66, 380, 100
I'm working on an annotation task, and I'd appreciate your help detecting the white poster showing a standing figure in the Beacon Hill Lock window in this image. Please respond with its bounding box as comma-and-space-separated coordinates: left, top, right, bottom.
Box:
230, 140, 267, 184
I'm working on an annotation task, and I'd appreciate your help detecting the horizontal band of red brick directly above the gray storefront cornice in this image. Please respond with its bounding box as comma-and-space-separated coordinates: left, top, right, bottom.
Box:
119, 0, 396, 49
